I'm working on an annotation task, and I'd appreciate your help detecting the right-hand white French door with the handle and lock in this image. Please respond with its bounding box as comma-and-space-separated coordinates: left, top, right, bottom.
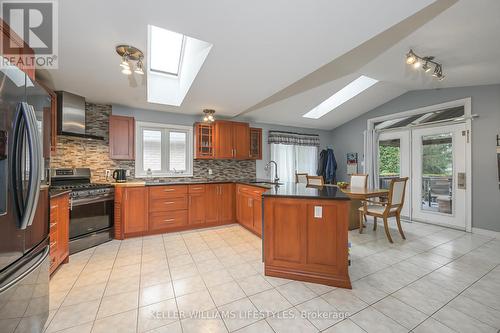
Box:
412, 124, 468, 229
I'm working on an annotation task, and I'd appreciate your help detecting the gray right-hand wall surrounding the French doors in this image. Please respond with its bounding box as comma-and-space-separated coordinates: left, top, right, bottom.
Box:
332, 85, 500, 231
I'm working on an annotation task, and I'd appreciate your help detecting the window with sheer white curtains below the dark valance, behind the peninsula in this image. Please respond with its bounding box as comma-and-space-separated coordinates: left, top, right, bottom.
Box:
271, 143, 318, 182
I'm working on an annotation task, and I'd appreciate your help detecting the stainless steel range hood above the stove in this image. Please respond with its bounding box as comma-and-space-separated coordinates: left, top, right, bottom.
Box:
56, 91, 104, 140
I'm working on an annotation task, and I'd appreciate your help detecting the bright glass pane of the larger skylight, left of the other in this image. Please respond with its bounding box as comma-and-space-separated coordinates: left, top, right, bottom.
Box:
149, 25, 184, 75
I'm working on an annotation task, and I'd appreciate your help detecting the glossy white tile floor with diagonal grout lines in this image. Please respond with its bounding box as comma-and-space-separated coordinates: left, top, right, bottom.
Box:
46, 219, 500, 333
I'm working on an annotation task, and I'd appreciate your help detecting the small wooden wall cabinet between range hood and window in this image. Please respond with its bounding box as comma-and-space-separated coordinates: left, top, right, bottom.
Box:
109, 115, 135, 160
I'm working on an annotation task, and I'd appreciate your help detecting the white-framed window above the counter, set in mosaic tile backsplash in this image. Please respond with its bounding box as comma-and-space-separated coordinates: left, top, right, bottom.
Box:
135, 122, 193, 177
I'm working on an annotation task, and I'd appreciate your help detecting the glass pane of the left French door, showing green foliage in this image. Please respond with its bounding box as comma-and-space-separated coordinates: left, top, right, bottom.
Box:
378, 139, 401, 189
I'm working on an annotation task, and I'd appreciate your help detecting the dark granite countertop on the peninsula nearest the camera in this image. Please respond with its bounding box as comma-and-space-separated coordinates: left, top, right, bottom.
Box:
262, 183, 350, 200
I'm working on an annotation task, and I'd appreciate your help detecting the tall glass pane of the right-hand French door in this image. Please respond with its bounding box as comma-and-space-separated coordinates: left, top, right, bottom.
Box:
422, 133, 453, 214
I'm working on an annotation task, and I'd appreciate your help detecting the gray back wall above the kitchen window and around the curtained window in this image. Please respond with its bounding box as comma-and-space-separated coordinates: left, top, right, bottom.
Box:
113, 105, 332, 179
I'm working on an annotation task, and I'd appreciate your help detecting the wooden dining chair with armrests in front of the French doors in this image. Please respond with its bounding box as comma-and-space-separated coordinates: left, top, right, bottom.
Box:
359, 177, 408, 243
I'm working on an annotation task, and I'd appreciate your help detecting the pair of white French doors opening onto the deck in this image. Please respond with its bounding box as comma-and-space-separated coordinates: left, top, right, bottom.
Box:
377, 124, 470, 230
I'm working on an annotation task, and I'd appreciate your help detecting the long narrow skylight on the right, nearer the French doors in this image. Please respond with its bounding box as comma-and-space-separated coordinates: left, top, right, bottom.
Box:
302, 75, 378, 119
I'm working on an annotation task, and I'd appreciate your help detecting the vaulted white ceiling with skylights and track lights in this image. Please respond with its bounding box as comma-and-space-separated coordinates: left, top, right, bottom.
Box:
42, 0, 500, 129
